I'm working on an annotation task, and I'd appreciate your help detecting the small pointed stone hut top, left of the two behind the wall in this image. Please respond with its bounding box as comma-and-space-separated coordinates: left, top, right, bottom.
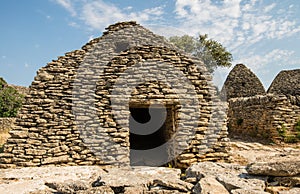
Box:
221, 64, 266, 99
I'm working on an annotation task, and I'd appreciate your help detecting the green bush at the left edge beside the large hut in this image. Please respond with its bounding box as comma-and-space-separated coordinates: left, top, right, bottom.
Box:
0, 77, 24, 117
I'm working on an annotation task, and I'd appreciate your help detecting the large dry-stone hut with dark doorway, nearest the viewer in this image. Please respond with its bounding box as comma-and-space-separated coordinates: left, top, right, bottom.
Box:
0, 22, 228, 168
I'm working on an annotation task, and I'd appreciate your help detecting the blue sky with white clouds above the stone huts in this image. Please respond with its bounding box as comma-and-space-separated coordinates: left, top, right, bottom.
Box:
0, 0, 300, 89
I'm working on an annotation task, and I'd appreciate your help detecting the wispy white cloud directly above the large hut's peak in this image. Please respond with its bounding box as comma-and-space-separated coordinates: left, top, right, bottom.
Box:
55, 0, 164, 30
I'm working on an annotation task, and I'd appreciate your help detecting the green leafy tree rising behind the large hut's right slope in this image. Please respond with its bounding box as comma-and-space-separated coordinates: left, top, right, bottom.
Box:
169, 34, 232, 73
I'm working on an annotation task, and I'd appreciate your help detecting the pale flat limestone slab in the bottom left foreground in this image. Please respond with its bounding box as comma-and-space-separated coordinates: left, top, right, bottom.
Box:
0, 166, 105, 194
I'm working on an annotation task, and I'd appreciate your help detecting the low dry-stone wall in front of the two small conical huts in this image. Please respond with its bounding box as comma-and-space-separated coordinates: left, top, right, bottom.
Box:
228, 94, 300, 142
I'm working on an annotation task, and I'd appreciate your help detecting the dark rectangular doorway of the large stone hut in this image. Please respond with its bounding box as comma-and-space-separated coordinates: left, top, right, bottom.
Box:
129, 107, 174, 166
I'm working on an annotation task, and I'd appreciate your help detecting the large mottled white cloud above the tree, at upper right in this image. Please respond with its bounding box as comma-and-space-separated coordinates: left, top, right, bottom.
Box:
175, 0, 300, 52
